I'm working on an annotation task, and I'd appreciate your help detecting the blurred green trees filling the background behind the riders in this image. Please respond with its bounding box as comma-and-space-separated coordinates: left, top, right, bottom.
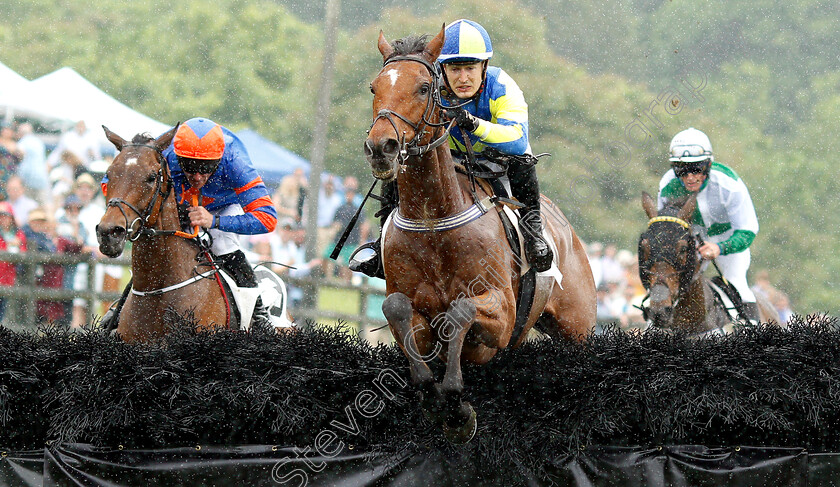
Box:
0, 0, 840, 314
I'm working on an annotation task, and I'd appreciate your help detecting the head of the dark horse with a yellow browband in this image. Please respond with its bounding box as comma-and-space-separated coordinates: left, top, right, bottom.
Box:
639, 193, 698, 327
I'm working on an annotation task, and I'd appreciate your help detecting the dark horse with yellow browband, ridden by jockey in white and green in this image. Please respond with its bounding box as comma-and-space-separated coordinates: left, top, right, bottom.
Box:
639, 192, 779, 336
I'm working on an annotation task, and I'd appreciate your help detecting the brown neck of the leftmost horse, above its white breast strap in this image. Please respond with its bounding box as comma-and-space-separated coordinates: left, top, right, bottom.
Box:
131, 195, 203, 289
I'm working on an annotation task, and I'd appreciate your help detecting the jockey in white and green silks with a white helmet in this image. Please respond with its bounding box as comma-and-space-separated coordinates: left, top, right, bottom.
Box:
658, 128, 758, 321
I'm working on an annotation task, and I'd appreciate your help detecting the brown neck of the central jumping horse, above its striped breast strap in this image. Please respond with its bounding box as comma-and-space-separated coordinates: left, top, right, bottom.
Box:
397, 144, 472, 220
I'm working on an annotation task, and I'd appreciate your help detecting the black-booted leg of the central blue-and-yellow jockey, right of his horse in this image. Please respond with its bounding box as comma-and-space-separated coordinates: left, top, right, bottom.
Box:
508, 163, 554, 272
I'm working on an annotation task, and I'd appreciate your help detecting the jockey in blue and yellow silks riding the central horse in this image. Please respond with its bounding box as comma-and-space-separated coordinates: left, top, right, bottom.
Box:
350, 19, 553, 277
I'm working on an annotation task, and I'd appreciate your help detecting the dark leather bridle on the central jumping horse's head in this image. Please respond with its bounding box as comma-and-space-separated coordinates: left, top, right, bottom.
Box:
368, 56, 455, 165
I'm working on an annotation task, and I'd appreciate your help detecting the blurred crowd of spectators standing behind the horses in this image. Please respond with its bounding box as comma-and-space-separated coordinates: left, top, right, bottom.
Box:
0, 121, 791, 329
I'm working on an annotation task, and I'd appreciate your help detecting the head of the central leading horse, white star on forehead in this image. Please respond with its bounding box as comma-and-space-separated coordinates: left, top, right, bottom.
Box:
365, 28, 444, 181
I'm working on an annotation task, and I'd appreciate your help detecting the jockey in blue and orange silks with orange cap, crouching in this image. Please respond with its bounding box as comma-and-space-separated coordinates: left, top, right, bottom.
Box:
102, 118, 277, 327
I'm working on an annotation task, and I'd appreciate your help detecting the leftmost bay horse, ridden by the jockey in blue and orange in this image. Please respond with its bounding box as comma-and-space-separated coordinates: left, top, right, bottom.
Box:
96, 126, 229, 342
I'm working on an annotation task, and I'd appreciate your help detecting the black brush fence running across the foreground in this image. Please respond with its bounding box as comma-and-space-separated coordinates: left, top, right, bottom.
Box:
0, 316, 840, 485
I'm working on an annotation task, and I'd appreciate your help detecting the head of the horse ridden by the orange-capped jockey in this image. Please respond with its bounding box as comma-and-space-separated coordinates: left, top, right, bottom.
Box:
96, 126, 178, 257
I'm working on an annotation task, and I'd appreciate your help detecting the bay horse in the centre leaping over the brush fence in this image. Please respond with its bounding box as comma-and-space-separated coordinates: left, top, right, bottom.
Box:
364, 29, 596, 443
